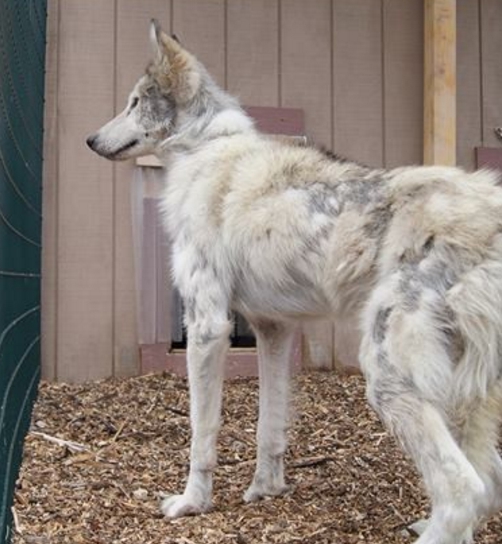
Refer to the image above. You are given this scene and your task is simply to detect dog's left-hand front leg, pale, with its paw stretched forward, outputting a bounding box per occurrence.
[162,302,231,518]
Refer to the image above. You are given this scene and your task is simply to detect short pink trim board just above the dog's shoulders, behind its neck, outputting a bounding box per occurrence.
[244,106,305,136]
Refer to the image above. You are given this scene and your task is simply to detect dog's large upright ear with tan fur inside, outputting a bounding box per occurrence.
[150,19,200,102]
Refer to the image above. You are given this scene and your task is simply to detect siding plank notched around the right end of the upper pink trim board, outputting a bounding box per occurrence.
[280,0,332,147]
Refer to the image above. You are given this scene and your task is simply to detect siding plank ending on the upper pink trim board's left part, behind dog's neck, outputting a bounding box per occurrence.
[226,0,279,106]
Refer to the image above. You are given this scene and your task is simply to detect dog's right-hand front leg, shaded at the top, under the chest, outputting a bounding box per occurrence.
[244,321,294,502]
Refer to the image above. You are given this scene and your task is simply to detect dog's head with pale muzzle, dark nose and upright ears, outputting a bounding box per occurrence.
[87,20,201,160]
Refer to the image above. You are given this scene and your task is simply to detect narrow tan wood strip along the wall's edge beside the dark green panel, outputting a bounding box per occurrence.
[41,0,59,380]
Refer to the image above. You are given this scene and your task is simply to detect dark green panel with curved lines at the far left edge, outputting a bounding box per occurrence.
[0,0,47,544]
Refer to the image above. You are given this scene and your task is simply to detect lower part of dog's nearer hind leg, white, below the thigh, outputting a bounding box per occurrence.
[370,386,485,544]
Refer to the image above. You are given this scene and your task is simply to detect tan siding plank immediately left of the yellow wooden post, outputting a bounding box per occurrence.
[383,0,424,167]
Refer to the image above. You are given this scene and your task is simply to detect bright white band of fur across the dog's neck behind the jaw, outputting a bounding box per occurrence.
[157,108,255,158]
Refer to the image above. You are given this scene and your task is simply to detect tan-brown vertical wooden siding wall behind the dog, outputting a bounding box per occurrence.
[42,0,502,381]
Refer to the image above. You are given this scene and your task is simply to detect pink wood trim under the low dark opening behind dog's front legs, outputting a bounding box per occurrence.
[140,332,302,378]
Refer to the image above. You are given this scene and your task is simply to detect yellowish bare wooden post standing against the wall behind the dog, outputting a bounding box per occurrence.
[424,0,456,165]
